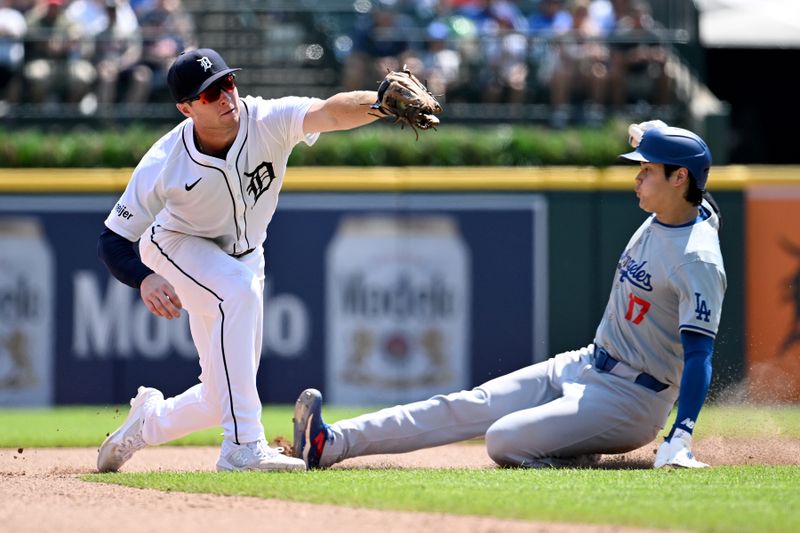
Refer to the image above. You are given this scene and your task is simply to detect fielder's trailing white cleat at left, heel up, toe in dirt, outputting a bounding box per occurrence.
[97,387,164,472]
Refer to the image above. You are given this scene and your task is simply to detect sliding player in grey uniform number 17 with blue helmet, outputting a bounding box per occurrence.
[294,121,726,468]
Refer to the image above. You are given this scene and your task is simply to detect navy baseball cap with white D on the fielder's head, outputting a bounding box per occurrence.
[167,48,242,102]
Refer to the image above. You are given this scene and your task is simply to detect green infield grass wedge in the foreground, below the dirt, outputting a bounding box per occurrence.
[83,466,800,532]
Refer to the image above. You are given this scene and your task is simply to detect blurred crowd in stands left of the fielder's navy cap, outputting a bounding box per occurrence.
[0,0,196,112]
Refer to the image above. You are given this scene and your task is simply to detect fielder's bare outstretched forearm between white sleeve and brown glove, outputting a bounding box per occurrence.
[303,91,379,134]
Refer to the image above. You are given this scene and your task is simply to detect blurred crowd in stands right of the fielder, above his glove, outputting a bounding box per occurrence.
[345,0,673,127]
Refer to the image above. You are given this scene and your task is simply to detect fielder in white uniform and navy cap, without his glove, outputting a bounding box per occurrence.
[97,48,384,472]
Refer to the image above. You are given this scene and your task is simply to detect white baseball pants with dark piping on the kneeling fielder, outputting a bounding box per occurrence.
[139,226,264,445]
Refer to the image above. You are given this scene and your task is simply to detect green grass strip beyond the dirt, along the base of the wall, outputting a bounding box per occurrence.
[0,405,800,448]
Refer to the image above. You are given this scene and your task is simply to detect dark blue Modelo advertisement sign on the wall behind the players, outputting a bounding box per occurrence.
[0,193,549,405]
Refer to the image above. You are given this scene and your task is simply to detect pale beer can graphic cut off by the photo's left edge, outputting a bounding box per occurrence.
[0,218,54,406]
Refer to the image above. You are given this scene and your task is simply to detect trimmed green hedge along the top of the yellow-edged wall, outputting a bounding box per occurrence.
[0,123,627,168]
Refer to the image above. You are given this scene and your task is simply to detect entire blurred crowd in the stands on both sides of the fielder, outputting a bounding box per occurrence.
[0,0,674,128]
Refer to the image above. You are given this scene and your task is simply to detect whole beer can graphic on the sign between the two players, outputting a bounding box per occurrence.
[325,216,470,404]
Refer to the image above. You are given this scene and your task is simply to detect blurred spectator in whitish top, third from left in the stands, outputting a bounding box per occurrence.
[93,0,153,104]
